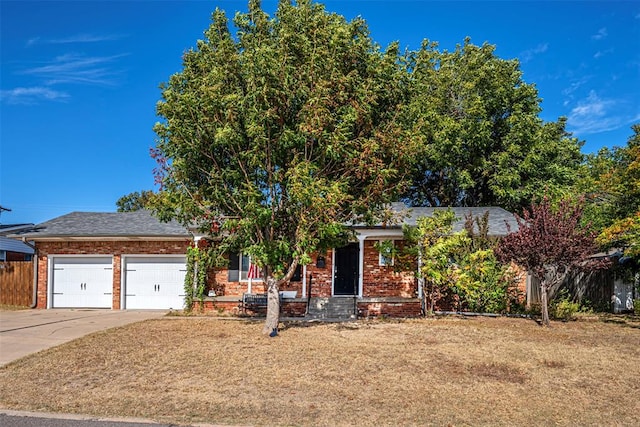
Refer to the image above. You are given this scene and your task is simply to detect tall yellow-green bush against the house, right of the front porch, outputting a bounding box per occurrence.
[388,209,520,313]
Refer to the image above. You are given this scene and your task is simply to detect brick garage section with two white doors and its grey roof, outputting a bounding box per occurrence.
[11,211,192,309]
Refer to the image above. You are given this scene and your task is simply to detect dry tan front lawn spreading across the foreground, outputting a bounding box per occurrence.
[0,318,640,426]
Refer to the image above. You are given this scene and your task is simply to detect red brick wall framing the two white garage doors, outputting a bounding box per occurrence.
[37,240,189,309]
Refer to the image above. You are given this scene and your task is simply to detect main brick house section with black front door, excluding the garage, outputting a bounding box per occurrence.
[204,203,517,318]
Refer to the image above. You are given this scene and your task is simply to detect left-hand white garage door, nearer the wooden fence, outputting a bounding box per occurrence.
[51,257,113,308]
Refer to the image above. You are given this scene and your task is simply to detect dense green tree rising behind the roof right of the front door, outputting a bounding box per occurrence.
[405,39,582,211]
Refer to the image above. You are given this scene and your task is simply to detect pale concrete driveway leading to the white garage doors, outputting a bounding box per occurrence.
[0,309,167,366]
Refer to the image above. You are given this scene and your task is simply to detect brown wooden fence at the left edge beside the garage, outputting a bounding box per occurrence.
[0,261,33,306]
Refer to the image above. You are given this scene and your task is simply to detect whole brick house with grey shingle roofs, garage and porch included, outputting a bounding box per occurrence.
[12,204,516,317]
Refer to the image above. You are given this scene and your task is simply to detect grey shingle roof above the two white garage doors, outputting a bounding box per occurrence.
[11,210,190,240]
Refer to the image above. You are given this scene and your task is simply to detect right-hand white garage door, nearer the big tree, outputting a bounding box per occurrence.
[124,256,187,310]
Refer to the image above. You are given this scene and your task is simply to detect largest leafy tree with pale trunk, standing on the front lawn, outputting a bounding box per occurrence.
[153,0,414,334]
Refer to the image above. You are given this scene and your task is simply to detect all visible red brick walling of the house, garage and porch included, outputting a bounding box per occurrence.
[37,240,420,317]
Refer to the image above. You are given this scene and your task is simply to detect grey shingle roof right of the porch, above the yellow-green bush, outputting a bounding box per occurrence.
[360,203,518,237]
